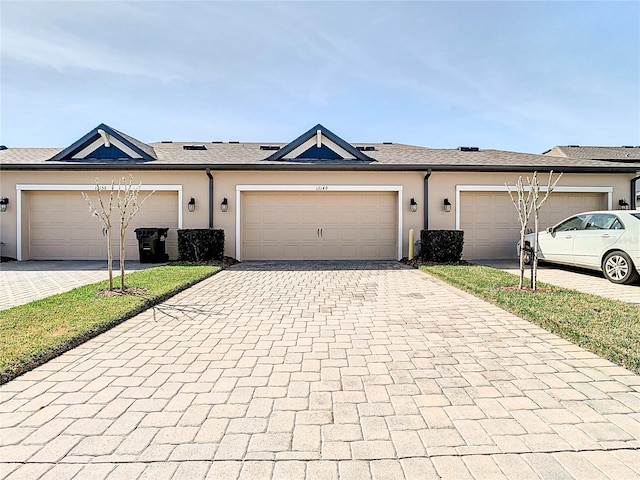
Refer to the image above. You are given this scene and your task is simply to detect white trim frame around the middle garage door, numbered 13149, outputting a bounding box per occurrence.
[236,185,402,260]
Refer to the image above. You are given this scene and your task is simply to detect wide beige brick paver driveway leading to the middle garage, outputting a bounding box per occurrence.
[0,262,640,480]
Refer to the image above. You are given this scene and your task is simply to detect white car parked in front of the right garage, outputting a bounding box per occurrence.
[518,210,640,284]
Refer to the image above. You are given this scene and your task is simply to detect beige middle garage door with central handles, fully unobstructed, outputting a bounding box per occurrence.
[241,192,398,260]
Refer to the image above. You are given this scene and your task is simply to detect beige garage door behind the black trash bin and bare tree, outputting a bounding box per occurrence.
[25,191,178,261]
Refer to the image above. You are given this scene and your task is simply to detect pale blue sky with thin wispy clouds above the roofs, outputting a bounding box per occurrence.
[0,0,640,153]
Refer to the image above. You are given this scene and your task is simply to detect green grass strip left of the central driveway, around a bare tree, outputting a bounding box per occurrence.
[0,265,221,384]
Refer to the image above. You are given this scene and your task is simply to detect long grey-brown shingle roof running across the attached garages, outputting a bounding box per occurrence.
[0,142,640,172]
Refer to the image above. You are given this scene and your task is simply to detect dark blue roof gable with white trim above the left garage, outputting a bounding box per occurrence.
[49,123,157,163]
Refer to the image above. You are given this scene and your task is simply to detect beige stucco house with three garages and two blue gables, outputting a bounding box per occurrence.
[0,124,640,260]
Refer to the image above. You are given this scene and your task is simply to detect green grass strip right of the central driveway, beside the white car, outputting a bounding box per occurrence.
[420,265,640,373]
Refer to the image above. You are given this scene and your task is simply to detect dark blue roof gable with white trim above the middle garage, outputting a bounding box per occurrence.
[265,124,375,163]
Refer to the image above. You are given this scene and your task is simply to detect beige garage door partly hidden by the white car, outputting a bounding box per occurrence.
[459,192,607,259]
